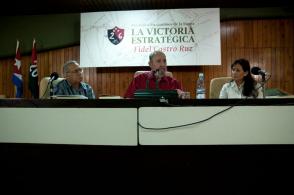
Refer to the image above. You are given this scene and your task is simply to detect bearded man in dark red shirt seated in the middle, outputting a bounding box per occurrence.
[124,51,184,98]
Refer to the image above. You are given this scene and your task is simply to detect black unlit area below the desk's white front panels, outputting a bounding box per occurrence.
[0,144,294,194]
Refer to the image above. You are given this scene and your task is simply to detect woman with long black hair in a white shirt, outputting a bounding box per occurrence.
[219,59,263,99]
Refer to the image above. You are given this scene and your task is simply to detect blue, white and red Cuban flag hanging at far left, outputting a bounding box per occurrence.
[12,41,23,98]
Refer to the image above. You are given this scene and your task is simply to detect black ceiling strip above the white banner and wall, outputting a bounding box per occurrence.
[0,0,293,16]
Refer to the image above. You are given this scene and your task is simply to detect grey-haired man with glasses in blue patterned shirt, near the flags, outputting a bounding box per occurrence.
[54,60,95,99]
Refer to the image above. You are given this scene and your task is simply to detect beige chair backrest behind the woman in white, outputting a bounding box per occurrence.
[209,77,232,99]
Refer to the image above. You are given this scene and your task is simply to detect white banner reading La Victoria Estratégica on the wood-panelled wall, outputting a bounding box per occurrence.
[80,8,221,67]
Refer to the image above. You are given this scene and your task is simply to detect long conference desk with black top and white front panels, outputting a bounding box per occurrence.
[0,98,294,146]
